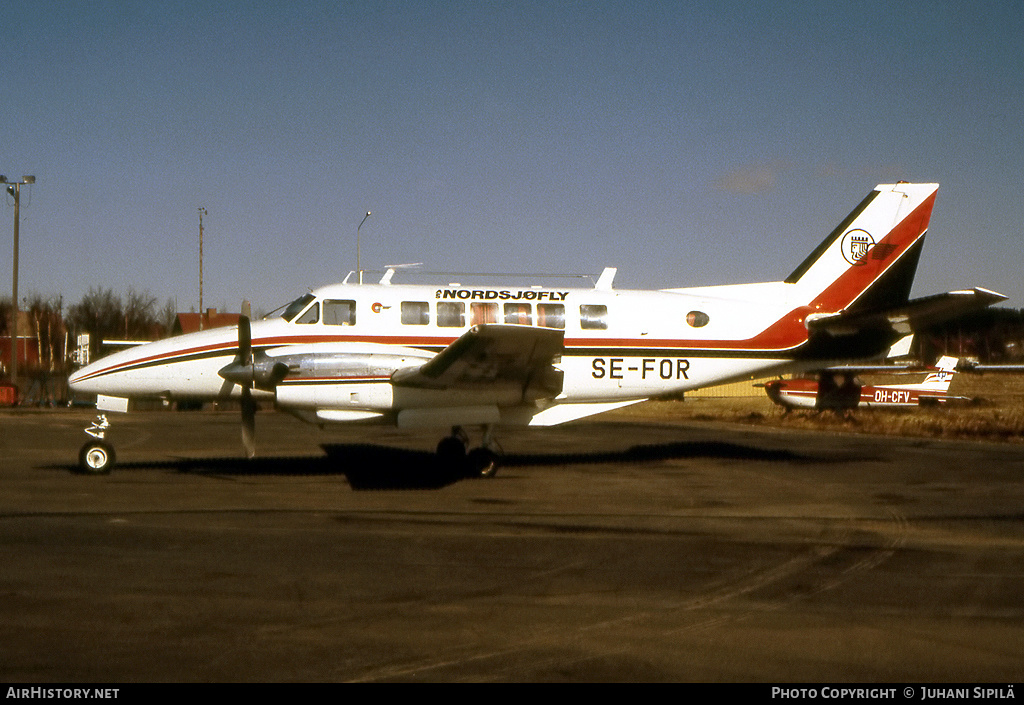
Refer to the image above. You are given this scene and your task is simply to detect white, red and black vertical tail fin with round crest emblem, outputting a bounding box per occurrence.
[785,181,939,314]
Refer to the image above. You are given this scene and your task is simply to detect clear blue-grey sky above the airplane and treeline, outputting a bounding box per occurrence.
[0,0,1024,310]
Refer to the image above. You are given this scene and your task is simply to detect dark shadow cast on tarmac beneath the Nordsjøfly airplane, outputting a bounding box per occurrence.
[58,441,823,490]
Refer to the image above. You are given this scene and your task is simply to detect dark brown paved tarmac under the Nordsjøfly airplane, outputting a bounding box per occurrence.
[0,410,1024,683]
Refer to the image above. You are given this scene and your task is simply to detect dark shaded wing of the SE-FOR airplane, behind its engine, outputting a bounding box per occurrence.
[391,324,564,400]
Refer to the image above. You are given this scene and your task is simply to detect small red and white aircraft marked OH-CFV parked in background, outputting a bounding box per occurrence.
[764,356,959,411]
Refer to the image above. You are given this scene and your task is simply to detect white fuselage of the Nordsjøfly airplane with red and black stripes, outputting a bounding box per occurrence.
[71,283,807,425]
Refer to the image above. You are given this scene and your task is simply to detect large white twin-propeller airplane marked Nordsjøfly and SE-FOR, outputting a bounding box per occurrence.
[69,182,1006,475]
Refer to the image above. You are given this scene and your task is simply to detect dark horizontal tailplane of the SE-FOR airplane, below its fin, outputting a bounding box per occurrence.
[807,288,1007,336]
